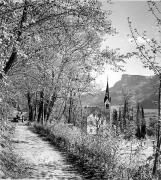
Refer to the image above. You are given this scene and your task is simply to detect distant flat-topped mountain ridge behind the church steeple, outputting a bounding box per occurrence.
[82,74,157,109]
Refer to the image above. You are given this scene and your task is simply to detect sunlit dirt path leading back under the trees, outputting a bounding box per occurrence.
[13,124,83,180]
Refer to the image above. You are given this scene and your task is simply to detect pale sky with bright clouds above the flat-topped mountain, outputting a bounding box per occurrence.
[96,0,158,89]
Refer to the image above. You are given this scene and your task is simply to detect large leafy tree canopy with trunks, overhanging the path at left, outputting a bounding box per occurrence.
[0,0,127,126]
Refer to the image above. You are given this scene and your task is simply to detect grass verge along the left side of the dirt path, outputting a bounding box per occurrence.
[0,120,31,179]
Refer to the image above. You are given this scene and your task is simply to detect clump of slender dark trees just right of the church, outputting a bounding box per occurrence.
[111,89,146,140]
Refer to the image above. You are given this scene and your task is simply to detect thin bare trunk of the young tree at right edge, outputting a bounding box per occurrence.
[152,74,161,175]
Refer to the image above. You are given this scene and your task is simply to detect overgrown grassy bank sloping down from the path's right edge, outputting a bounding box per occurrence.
[31,123,158,180]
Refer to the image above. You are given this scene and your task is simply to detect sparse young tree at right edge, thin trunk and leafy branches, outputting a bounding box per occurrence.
[128,1,161,175]
